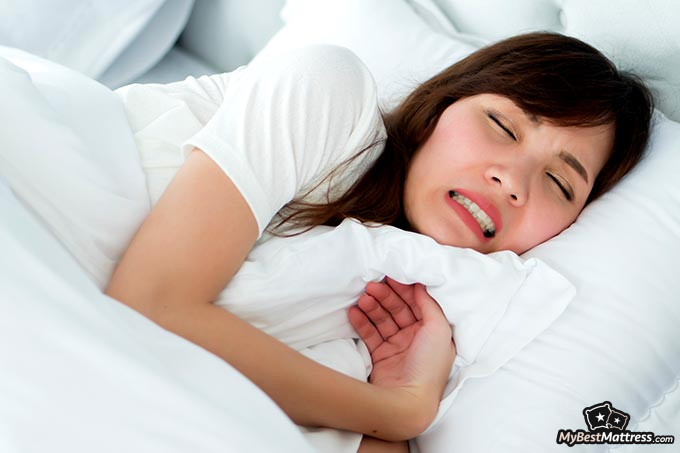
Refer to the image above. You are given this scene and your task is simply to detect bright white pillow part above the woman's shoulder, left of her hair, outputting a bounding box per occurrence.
[255,0,475,108]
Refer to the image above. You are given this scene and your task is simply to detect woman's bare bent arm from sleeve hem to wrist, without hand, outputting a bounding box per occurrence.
[106,150,443,440]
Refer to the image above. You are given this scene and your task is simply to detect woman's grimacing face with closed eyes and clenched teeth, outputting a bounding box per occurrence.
[404,94,614,254]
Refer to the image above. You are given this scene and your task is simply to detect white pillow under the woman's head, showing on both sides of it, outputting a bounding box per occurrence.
[263,0,680,446]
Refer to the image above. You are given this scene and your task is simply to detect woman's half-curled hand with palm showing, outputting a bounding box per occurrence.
[349,278,456,426]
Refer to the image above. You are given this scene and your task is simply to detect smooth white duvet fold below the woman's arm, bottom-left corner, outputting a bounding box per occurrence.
[0,177,314,453]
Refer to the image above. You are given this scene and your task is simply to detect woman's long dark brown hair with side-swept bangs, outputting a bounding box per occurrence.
[270,33,653,230]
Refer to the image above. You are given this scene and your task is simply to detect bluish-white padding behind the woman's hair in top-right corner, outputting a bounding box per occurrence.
[430,0,680,121]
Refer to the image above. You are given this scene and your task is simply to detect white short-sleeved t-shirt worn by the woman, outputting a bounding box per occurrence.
[116,46,385,235]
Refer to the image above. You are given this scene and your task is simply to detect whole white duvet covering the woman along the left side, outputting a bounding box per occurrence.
[0,48,310,453]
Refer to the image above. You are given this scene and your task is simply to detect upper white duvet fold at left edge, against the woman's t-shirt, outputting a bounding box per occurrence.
[0,46,150,288]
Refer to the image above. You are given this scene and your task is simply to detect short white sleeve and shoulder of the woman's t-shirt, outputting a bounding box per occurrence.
[182,46,384,235]
